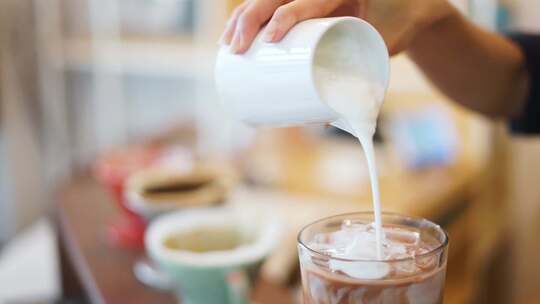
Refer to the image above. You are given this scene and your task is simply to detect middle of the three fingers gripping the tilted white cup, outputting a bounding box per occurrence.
[230,0,286,54]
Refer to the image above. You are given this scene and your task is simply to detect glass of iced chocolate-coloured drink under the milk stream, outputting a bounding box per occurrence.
[299,213,448,304]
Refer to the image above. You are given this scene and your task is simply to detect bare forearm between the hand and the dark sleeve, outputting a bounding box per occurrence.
[408,7,528,117]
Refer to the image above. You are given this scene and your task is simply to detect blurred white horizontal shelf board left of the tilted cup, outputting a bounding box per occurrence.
[61,37,217,79]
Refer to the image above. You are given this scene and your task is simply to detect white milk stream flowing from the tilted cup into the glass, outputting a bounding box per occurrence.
[314,23,385,260]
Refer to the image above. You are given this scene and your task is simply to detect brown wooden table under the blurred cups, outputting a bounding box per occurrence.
[56,174,294,304]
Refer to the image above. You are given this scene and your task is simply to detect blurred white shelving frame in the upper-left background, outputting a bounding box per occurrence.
[35,0,227,164]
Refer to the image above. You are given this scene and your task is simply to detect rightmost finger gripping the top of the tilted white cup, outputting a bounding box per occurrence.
[263,0,342,42]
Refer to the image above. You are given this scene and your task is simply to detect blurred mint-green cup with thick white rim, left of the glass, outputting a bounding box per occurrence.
[145,206,282,304]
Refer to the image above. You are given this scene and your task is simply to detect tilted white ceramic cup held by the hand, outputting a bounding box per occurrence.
[215,17,390,131]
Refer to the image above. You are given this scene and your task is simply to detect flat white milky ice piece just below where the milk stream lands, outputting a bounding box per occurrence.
[329,260,390,280]
